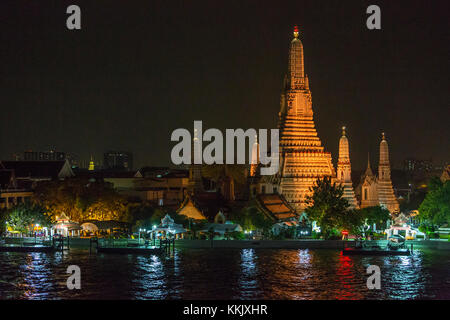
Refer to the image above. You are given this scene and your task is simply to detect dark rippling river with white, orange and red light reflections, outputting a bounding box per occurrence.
[0,249,450,299]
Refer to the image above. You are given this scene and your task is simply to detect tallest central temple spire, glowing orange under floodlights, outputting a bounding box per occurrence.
[279,27,335,210]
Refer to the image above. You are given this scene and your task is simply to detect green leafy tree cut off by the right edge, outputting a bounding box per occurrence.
[419,177,450,226]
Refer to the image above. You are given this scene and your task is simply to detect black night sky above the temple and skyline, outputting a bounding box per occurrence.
[0,0,450,169]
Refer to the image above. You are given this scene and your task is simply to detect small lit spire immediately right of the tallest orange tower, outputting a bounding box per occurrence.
[336,127,358,209]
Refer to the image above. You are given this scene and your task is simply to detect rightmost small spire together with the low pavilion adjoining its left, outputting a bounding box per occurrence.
[357,133,400,213]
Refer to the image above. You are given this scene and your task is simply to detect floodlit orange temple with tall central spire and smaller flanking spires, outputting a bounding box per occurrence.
[250,27,399,213]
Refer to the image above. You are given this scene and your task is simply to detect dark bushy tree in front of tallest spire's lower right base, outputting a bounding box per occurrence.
[305,177,357,238]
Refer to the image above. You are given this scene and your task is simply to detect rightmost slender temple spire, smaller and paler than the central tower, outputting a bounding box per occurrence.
[378,132,400,213]
